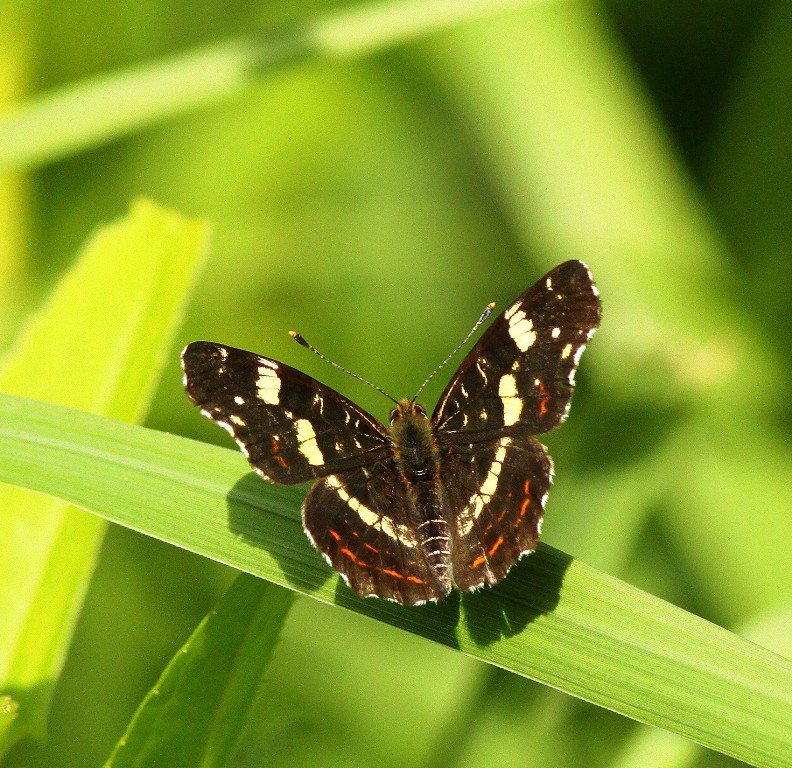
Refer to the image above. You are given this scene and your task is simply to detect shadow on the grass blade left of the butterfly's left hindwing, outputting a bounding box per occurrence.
[226,472,333,592]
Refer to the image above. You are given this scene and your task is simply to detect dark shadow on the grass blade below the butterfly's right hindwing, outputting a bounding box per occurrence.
[462,544,573,646]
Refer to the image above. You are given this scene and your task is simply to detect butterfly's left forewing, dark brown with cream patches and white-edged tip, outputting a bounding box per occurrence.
[182,341,390,484]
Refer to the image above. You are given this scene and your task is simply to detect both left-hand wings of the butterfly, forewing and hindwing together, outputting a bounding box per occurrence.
[182,341,451,605]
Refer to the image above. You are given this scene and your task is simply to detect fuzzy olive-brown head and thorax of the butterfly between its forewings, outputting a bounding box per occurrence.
[390,400,439,483]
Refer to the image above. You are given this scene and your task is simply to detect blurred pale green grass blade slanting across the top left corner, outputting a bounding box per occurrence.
[0,0,536,173]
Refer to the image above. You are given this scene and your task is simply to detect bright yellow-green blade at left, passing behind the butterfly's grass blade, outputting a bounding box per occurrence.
[0,202,206,752]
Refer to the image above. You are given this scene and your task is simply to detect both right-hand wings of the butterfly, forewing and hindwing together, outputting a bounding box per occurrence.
[432,261,600,589]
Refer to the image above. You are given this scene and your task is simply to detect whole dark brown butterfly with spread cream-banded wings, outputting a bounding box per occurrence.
[182,261,601,605]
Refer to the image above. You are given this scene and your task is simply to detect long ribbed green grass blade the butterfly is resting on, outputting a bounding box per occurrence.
[0,396,792,768]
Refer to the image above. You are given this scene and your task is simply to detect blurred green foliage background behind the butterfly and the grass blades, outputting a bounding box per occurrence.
[0,0,792,768]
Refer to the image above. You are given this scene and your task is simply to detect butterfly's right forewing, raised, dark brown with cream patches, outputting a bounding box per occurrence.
[432,261,600,444]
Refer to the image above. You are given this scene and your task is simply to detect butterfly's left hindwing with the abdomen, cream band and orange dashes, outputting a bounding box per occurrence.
[303,462,451,605]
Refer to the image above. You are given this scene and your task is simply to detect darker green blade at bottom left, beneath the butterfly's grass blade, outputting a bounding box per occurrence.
[105,574,294,768]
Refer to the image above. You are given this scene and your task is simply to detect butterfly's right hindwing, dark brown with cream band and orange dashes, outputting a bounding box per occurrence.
[441,437,553,589]
